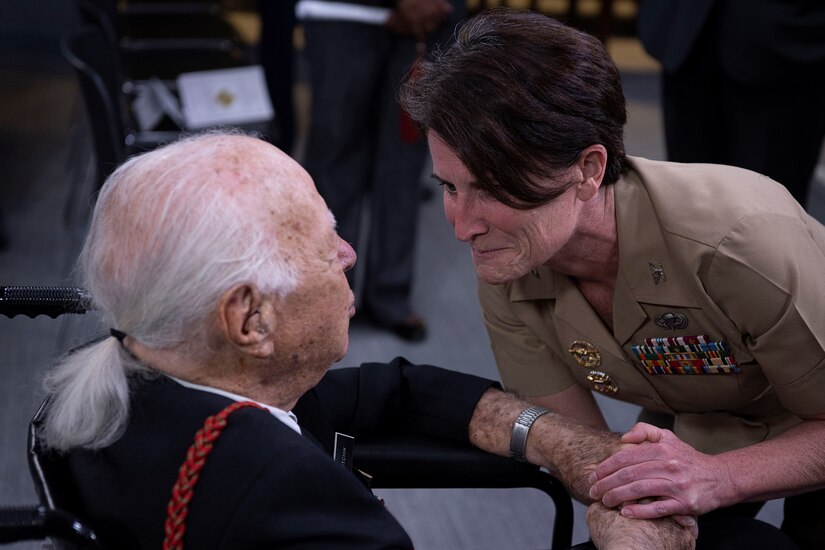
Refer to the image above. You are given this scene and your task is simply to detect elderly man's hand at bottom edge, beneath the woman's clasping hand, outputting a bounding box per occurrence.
[587,502,697,550]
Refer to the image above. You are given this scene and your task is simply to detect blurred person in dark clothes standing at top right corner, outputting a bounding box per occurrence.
[638,0,825,206]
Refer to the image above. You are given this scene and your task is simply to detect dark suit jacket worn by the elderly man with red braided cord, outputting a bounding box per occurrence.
[62,359,493,549]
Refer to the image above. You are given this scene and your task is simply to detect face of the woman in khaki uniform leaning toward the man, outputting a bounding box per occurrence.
[427,131,577,284]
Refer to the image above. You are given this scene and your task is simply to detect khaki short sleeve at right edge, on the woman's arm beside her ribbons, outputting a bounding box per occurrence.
[704,211,825,416]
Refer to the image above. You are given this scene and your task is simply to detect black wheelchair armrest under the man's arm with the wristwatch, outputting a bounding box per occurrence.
[353,435,573,548]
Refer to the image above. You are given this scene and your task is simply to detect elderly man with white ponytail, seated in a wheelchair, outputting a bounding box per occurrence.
[43,134,693,548]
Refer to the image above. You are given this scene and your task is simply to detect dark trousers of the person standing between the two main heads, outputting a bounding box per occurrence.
[304,21,427,322]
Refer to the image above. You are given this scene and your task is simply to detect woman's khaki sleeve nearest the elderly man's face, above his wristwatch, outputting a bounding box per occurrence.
[478,280,576,397]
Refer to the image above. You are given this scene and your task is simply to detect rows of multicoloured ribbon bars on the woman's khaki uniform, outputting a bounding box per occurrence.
[631,335,740,375]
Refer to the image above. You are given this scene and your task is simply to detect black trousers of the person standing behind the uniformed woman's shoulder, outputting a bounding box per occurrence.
[662,13,825,205]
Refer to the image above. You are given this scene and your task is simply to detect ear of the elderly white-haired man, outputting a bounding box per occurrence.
[218,284,275,358]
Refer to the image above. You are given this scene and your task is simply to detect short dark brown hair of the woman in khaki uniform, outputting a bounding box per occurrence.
[400,9,627,208]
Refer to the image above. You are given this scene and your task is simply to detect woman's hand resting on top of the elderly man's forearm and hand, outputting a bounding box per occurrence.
[590,423,735,518]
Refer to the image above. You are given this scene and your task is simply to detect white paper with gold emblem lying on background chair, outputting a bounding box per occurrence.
[177,65,274,130]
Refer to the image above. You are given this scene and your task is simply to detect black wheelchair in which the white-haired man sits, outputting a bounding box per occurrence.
[0,286,573,548]
